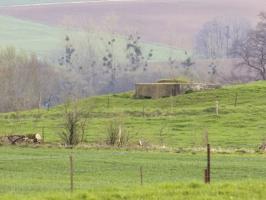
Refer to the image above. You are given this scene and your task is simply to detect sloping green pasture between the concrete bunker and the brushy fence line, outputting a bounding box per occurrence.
[0,81,266,150]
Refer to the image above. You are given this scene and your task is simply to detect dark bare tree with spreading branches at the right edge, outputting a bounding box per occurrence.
[233,13,266,80]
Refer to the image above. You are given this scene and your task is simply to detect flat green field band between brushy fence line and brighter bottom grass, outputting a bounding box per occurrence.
[0,147,266,196]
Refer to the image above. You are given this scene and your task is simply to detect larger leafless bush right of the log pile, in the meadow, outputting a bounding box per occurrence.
[60,101,86,146]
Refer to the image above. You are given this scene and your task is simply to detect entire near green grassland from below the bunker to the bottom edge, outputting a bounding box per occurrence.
[0,81,266,200]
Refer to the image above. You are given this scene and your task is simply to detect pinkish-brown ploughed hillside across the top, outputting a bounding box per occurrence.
[0,0,265,49]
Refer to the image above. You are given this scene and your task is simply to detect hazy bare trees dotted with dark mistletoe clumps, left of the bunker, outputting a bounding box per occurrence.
[56,30,153,97]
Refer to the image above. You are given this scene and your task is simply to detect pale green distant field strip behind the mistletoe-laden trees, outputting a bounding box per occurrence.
[0,16,187,62]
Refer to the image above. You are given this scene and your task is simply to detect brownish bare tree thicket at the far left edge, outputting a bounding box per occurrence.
[0,47,59,112]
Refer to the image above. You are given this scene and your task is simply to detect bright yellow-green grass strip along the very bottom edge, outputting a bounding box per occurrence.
[0,181,266,200]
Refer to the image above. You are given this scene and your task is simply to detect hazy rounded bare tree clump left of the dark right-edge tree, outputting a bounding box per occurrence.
[195,18,250,59]
